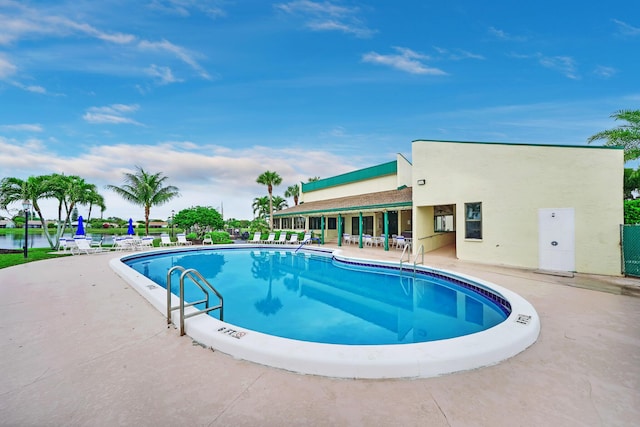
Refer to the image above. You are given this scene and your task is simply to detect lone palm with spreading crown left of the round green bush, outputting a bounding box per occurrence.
[107,166,180,235]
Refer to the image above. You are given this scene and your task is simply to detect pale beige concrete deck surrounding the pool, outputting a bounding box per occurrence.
[0,246,640,426]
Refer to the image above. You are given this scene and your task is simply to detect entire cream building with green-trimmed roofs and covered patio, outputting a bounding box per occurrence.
[274,140,624,275]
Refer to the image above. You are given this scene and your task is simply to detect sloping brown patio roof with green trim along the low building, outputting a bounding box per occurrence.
[273,187,413,218]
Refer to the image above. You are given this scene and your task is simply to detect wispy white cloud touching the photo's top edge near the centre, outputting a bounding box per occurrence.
[274,0,375,38]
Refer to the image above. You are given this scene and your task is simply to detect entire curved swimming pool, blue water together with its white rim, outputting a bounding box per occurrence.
[112,245,539,378]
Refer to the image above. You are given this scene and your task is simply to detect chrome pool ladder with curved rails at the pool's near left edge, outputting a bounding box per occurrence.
[167,265,224,336]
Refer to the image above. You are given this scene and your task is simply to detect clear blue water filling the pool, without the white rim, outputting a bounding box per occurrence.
[125,248,509,345]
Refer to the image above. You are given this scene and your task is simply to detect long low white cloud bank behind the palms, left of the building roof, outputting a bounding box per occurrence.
[0,136,360,219]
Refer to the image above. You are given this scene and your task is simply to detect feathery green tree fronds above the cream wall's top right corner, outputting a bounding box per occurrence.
[587,110,640,161]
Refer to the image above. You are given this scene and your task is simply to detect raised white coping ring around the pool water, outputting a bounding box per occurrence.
[109,245,540,379]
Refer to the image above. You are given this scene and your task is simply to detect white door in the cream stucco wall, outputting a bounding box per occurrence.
[538,208,576,271]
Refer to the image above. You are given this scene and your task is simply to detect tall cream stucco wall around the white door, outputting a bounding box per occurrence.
[412,141,624,275]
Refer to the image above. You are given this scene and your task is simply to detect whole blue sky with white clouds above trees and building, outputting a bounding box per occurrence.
[0,0,640,219]
